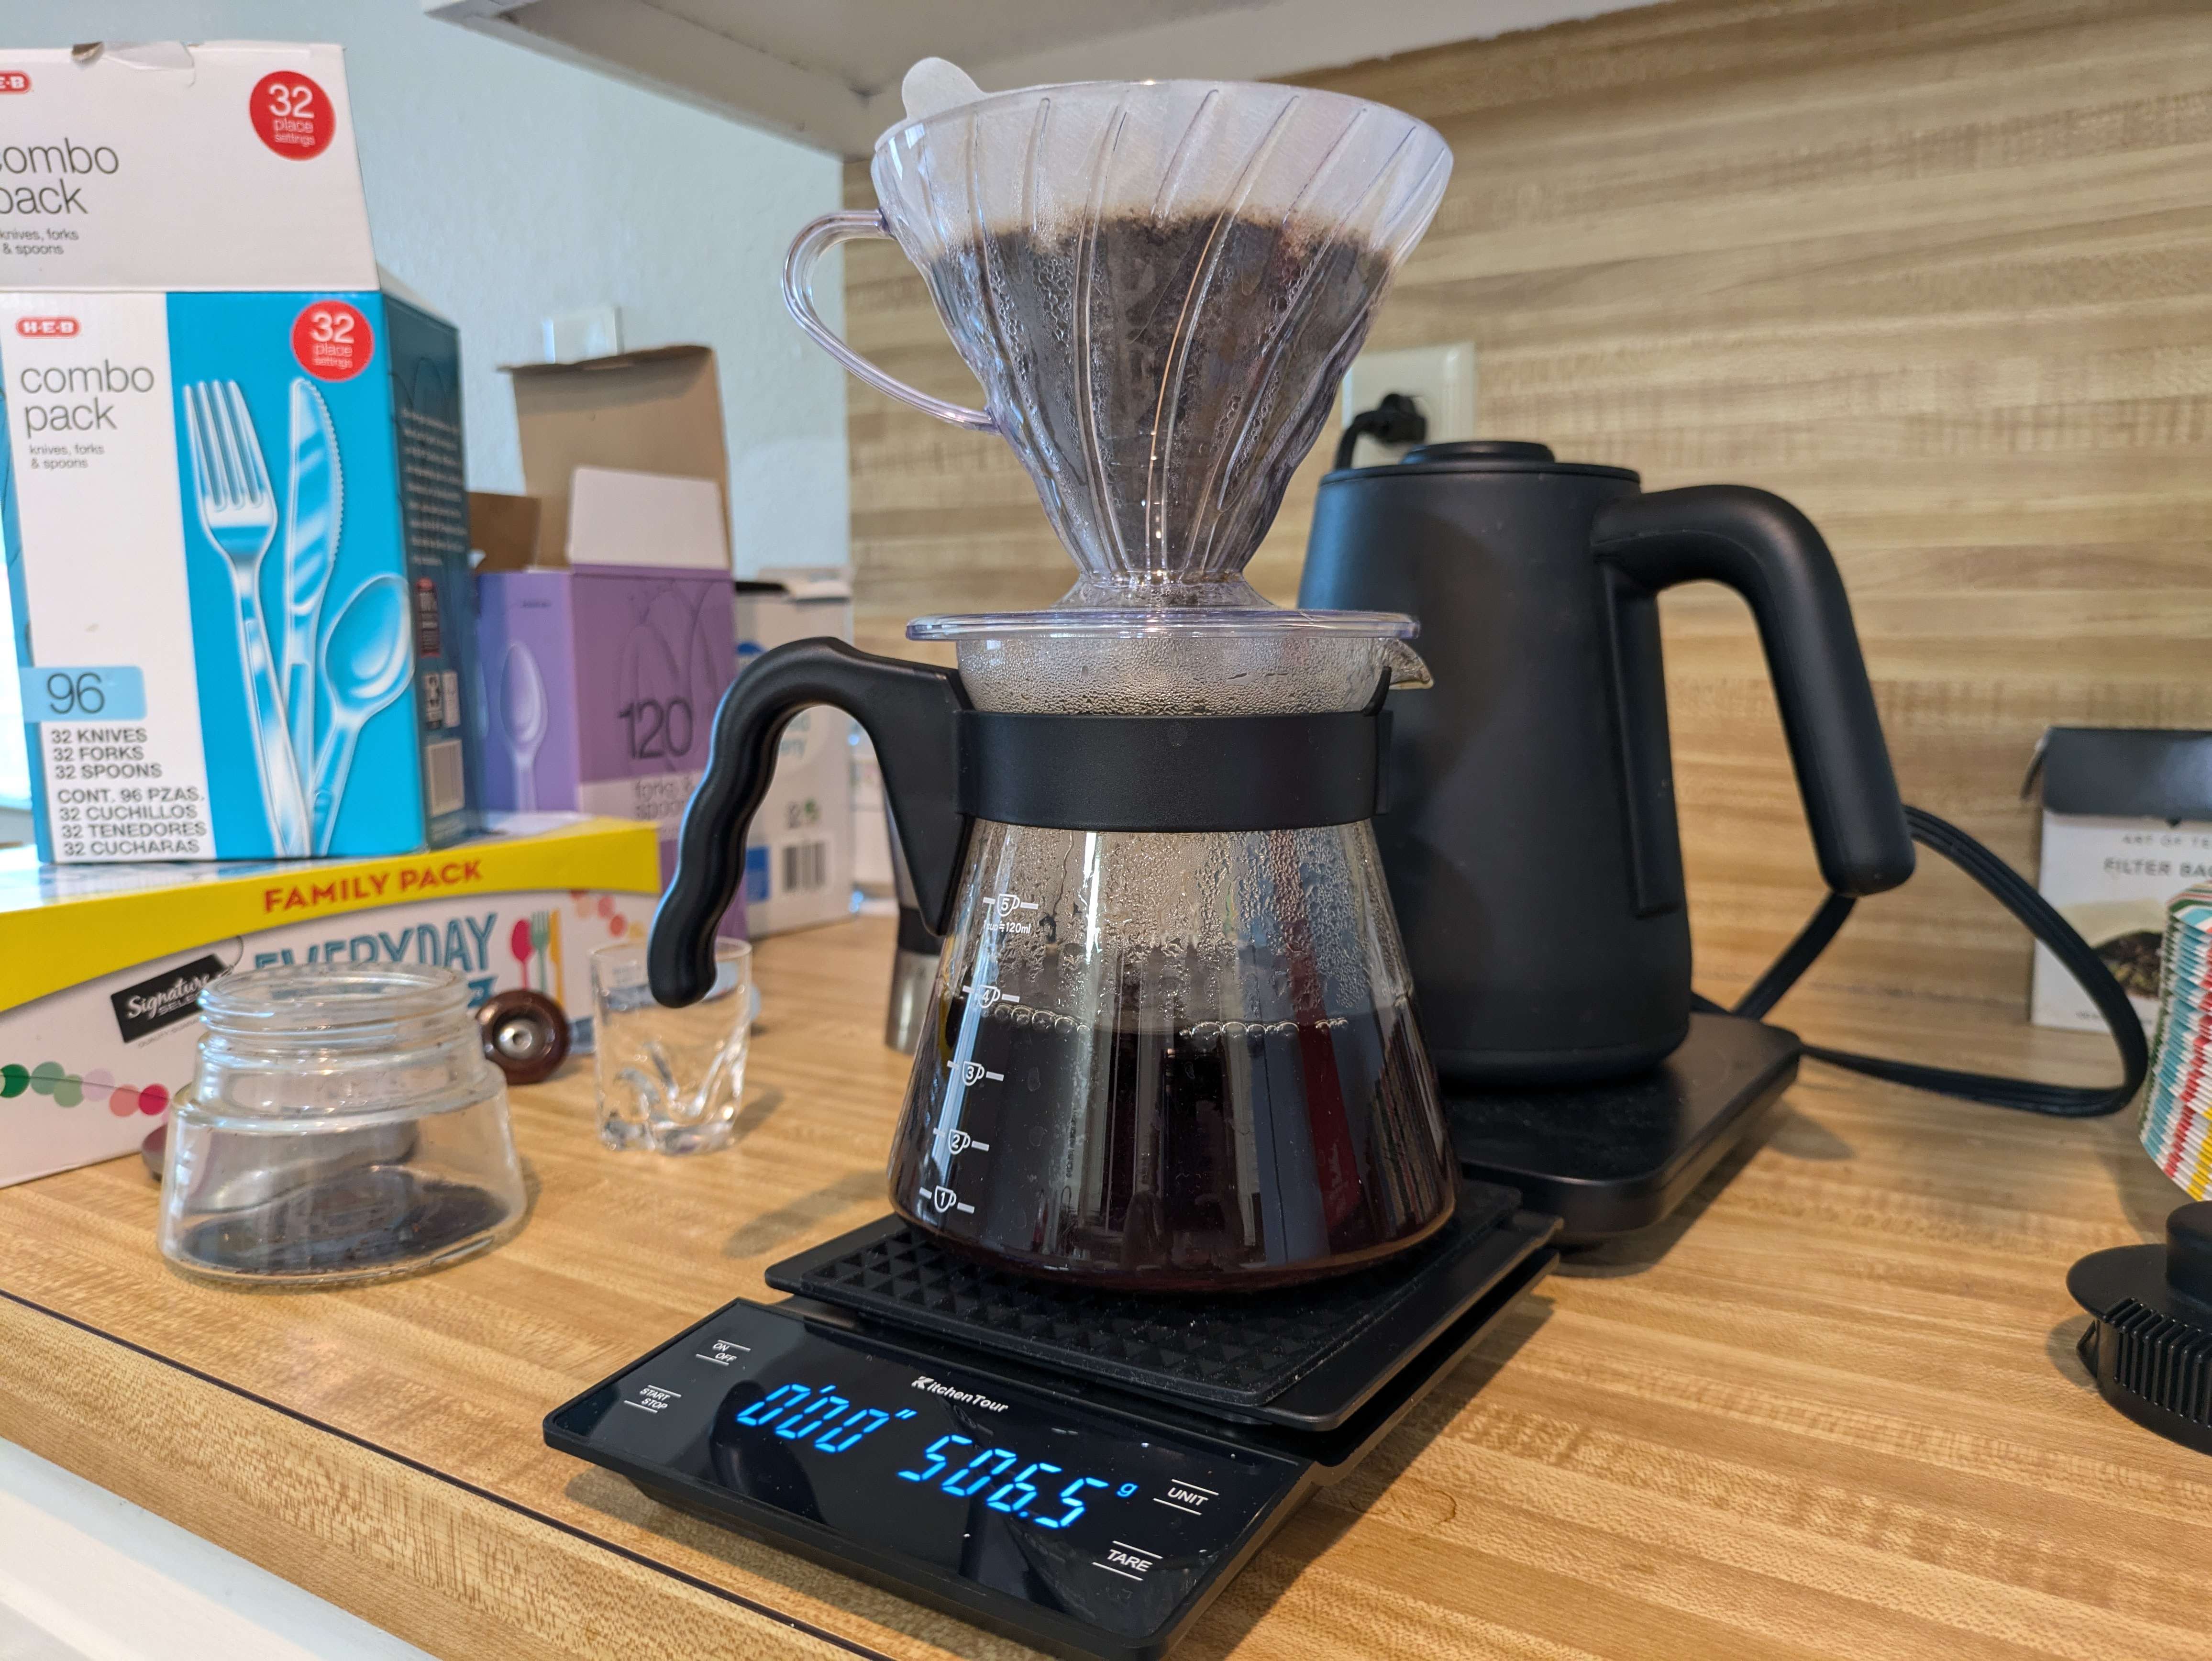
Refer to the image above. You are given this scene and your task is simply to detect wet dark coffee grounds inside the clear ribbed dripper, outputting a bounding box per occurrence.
[927,214,1389,575]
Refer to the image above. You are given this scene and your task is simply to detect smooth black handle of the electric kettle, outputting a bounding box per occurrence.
[1593,484,1913,898]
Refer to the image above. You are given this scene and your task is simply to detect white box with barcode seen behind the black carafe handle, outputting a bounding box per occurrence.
[737,568,854,938]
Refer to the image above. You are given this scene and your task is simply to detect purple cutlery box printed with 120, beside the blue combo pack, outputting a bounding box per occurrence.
[476,566,743,933]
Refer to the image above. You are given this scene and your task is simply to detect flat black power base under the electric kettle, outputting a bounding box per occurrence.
[1444,1013,1803,1245]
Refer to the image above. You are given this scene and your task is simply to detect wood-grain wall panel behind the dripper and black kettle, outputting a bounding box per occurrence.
[845,0,2212,1015]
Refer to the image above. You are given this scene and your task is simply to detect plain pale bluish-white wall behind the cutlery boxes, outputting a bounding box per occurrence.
[0,0,845,798]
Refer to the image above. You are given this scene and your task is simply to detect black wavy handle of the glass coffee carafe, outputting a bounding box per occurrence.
[646,639,971,1008]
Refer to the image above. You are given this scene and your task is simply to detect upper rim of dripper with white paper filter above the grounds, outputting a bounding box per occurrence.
[872,57,1451,263]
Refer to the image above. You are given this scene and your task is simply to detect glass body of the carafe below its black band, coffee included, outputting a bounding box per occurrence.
[891,825,1451,1289]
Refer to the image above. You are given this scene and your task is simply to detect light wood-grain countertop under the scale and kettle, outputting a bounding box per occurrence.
[0,920,2212,1661]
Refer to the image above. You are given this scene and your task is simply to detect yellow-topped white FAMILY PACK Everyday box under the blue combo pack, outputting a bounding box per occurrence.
[0,814,659,1183]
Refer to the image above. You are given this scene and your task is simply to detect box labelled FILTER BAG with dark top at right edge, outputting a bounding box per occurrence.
[2028,728,2212,1033]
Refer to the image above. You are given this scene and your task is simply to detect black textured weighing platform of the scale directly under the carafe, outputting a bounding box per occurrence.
[768,1183,1522,1422]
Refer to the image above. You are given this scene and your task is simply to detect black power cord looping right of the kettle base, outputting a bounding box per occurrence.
[1697,807,2150,1119]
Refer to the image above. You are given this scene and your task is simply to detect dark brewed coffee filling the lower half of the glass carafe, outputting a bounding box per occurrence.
[891,1000,1456,1292]
